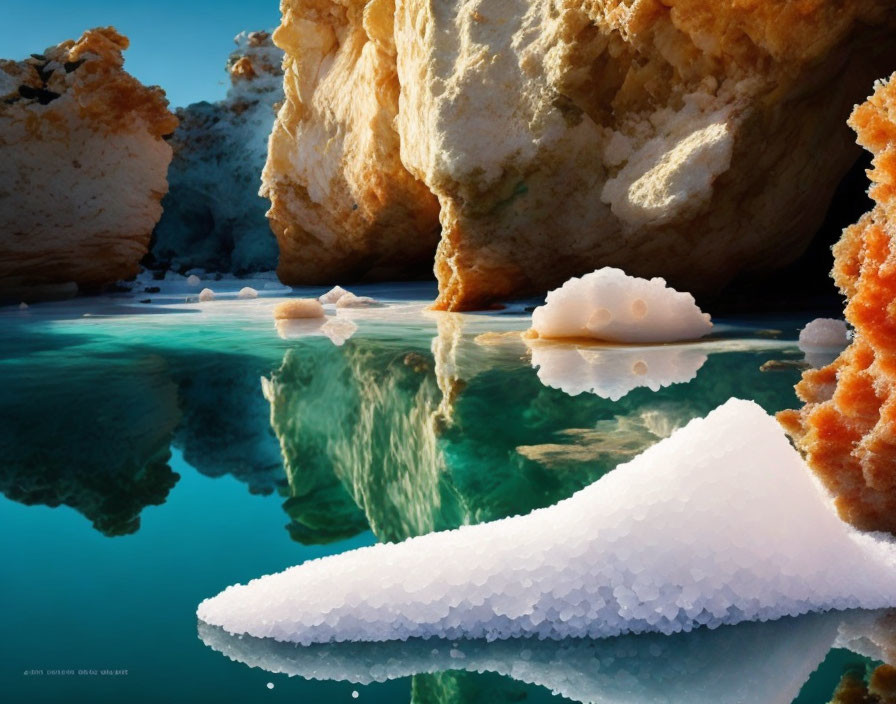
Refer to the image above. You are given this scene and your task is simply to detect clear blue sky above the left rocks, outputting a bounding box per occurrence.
[0,0,280,106]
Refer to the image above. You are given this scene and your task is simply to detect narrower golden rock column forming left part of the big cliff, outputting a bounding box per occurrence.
[262,0,439,284]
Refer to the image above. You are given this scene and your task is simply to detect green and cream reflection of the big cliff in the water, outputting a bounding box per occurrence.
[263,315,792,542]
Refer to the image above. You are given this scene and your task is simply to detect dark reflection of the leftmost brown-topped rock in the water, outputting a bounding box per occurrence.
[0,350,181,536]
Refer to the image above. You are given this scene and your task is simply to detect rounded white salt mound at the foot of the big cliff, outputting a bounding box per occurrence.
[532,267,712,342]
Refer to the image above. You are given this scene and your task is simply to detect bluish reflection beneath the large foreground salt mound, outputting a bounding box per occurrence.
[199,611,880,704]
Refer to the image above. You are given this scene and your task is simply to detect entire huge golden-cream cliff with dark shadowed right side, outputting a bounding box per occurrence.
[265,0,896,309]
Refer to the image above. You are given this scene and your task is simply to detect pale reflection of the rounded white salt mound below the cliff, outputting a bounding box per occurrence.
[530,341,707,401]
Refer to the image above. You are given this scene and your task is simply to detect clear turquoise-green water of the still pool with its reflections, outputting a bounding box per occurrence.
[0,285,870,704]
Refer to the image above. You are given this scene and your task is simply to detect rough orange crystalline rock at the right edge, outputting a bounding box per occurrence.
[779,74,896,533]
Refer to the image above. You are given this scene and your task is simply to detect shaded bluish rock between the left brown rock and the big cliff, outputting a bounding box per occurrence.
[152,32,283,274]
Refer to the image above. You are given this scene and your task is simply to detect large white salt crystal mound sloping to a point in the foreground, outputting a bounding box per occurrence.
[197,399,896,644]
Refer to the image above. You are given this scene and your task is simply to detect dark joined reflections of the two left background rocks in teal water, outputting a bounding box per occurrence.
[0,327,283,537]
